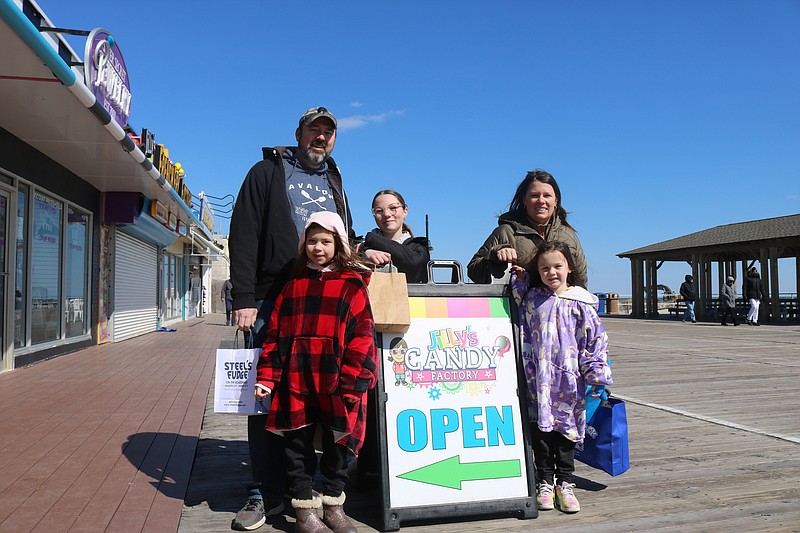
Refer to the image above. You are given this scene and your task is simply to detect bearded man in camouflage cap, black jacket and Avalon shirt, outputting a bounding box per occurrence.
[228,107,354,531]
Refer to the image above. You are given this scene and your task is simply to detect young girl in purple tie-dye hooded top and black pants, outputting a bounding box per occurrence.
[511,241,612,513]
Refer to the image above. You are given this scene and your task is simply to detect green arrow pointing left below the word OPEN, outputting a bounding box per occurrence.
[397,455,522,490]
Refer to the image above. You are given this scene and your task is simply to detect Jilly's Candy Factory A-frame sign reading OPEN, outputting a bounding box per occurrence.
[376,261,538,531]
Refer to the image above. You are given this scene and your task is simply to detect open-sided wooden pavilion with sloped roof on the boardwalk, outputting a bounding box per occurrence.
[617,215,800,322]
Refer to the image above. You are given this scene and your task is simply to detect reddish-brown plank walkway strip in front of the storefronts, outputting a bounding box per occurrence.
[0,317,224,532]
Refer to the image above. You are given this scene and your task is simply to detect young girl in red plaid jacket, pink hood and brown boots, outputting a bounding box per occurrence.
[255,211,378,533]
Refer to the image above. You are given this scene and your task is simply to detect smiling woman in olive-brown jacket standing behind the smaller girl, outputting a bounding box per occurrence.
[467,169,587,288]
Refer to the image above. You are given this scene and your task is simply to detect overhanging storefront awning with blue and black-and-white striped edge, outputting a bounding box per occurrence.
[0,0,199,231]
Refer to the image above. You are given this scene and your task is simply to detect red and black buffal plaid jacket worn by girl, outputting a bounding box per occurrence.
[257,269,378,453]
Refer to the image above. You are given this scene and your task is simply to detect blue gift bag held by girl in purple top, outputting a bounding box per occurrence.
[575,398,631,476]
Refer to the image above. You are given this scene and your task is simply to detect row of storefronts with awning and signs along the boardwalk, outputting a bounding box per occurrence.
[0,0,222,372]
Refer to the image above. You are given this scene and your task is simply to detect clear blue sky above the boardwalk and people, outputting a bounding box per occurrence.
[43,0,800,294]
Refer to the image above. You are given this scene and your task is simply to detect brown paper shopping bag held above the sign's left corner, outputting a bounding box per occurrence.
[368,272,411,333]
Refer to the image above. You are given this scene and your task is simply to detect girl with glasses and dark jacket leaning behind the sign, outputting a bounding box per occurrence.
[360,189,431,283]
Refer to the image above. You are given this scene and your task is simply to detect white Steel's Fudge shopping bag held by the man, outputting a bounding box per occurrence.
[214,339,272,415]
